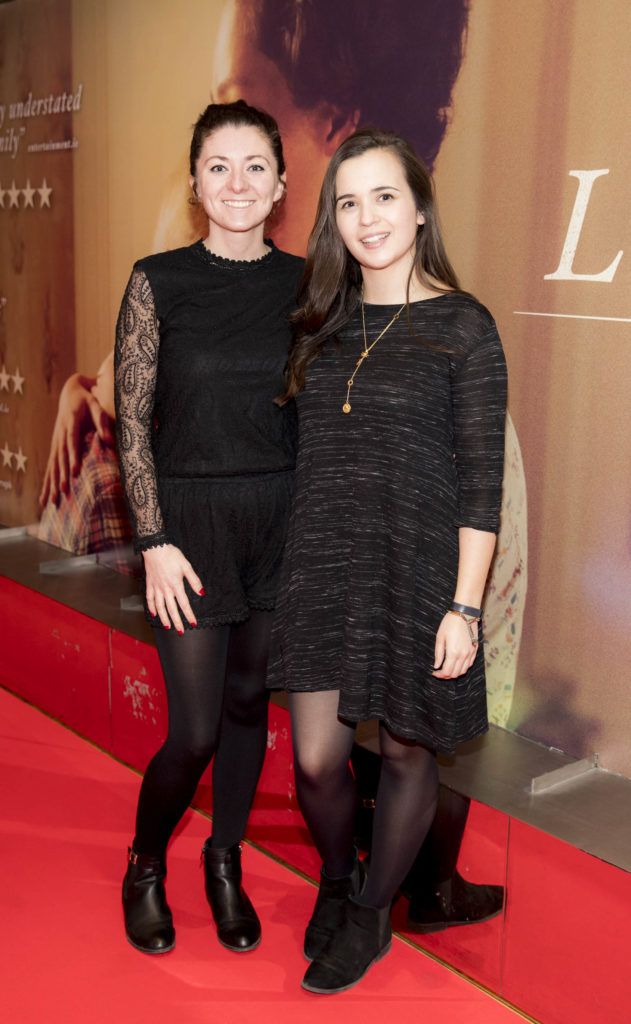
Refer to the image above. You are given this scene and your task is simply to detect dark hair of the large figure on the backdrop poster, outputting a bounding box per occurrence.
[256,0,470,168]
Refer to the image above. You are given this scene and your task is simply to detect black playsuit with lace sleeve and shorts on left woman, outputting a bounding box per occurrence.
[115,242,303,627]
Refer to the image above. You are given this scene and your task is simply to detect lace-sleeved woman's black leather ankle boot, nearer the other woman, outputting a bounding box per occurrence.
[202,840,261,953]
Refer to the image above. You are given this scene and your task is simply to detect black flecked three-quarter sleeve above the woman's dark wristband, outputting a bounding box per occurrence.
[452,326,507,534]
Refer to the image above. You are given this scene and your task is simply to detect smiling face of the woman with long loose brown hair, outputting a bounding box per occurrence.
[335,148,425,280]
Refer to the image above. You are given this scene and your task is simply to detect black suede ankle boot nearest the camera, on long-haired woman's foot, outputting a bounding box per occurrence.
[302,897,392,995]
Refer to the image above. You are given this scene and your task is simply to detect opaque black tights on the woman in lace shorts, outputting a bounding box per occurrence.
[134,611,271,857]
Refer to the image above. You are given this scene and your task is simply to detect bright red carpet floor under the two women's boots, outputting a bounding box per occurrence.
[0,690,517,1024]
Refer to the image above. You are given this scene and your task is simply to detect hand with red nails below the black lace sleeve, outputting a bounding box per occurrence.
[142,544,204,635]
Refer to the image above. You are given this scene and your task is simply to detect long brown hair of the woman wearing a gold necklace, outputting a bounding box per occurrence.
[277,127,461,406]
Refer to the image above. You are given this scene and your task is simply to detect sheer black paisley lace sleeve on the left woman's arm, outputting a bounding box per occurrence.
[115,268,169,552]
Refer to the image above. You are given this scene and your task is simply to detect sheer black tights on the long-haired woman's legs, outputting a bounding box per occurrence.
[289,690,438,907]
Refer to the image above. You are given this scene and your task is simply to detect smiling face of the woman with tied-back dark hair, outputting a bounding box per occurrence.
[191,125,284,238]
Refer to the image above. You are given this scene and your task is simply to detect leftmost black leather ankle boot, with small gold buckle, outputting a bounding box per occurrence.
[123,847,175,953]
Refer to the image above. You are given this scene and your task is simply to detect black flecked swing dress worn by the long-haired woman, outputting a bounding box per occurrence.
[268,292,506,753]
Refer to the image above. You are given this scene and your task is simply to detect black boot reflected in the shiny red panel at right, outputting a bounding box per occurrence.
[408,871,504,935]
